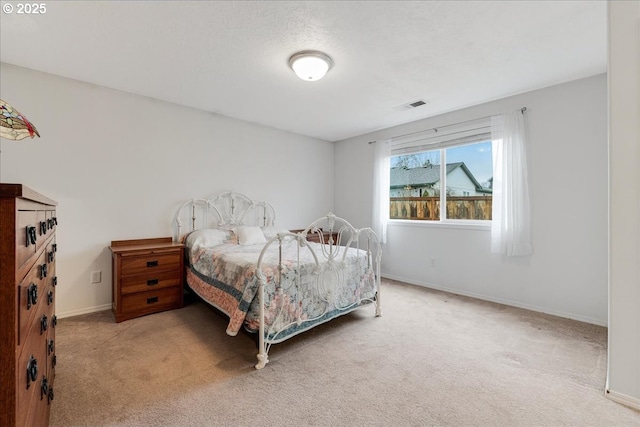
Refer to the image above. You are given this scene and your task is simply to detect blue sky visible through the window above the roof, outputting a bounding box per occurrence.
[391,141,493,184]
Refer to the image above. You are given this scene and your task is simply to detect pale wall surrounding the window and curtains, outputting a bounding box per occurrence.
[334,75,608,325]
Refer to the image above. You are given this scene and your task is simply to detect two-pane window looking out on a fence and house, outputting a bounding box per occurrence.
[389,140,493,221]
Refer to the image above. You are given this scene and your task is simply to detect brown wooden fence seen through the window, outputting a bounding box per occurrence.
[389,196,492,221]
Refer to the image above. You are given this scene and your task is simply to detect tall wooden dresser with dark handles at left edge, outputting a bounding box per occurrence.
[0,184,58,426]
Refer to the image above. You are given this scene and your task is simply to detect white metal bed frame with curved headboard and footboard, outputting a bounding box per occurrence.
[174,192,382,369]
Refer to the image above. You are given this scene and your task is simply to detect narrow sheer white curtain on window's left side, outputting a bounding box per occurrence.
[372,140,391,243]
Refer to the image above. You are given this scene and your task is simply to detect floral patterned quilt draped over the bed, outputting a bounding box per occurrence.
[187,236,376,343]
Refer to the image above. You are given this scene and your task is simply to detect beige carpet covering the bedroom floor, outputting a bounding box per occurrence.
[51,280,640,427]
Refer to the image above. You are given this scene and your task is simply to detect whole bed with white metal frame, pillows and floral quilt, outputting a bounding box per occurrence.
[174,192,381,369]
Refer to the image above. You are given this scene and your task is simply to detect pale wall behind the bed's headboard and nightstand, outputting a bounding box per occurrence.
[0,64,334,316]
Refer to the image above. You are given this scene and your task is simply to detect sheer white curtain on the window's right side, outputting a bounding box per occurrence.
[491,110,533,256]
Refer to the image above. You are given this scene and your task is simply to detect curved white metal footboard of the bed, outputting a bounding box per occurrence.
[255,213,381,369]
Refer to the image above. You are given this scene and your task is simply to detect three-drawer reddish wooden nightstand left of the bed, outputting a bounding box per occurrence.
[110,237,184,322]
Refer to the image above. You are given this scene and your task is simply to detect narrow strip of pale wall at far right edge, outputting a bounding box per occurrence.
[607,1,640,409]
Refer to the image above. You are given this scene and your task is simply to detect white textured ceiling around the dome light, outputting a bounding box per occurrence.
[0,1,607,141]
